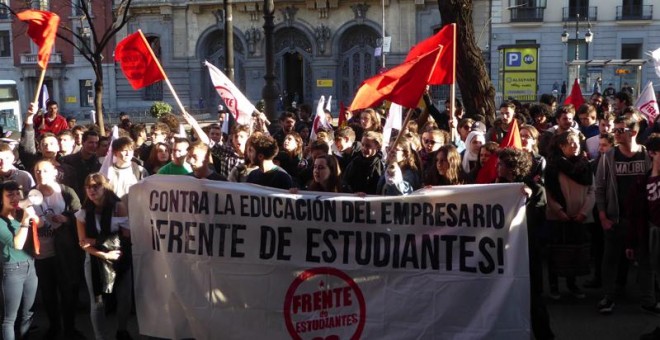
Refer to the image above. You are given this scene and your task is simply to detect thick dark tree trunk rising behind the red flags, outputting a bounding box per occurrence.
[438,0,496,125]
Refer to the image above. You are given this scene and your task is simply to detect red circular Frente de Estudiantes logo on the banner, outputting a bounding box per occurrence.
[284,267,366,340]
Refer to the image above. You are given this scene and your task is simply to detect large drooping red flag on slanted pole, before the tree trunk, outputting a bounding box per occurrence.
[351,46,442,110]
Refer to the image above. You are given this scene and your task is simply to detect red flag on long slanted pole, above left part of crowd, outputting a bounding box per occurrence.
[115,30,165,90]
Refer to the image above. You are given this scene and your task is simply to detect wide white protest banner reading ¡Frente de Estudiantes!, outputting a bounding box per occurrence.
[130,176,531,340]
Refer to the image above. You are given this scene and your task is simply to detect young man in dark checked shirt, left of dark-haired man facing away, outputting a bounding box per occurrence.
[211,124,250,178]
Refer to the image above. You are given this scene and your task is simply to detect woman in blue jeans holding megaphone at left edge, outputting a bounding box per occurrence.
[0,181,40,340]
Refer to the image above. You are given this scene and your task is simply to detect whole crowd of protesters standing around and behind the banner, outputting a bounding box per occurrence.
[0,87,660,340]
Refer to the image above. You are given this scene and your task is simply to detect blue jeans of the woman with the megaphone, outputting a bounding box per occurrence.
[2,260,38,340]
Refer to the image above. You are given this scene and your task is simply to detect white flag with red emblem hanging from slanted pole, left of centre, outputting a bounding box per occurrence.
[204,61,257,124]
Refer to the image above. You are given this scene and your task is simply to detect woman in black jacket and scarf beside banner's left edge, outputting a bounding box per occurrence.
[76,173,132,340]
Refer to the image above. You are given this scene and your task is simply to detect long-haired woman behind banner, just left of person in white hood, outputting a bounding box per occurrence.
[424,144,465,186]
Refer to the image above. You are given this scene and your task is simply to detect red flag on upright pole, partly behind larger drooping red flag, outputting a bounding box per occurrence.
[405,24,456,85]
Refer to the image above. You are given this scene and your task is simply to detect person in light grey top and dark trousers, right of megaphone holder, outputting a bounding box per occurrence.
[34,160,84,339]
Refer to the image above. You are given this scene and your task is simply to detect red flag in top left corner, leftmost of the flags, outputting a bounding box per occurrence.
[16,9,60,69]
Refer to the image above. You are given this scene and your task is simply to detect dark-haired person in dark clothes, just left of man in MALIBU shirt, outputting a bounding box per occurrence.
[545,130,595,299]
